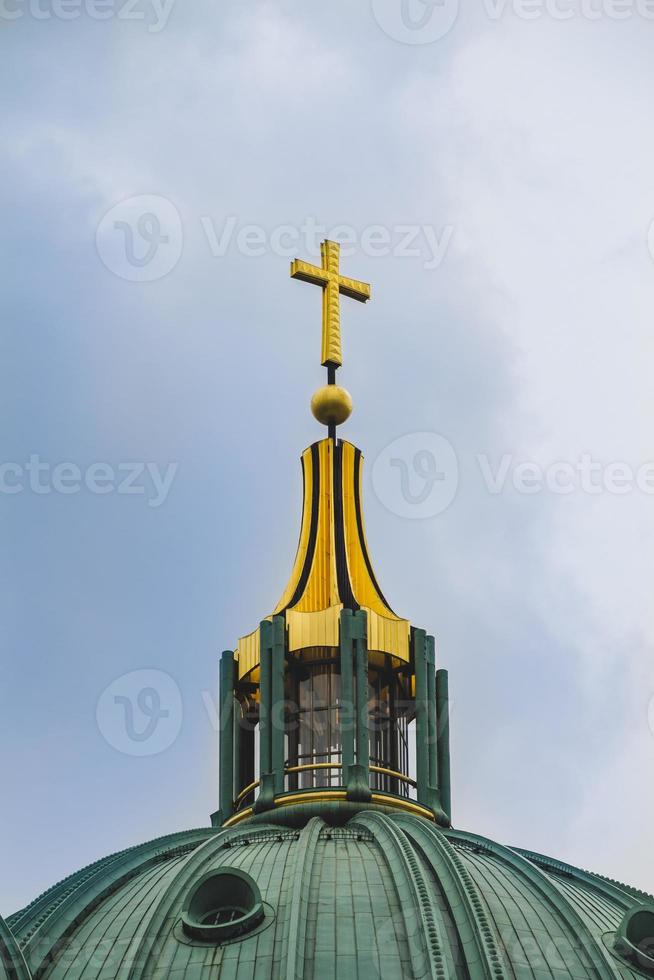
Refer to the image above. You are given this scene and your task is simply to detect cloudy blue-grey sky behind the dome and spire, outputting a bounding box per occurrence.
[0,0,654,914]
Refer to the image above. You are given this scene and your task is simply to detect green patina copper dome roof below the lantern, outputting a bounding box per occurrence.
[5,811,651,980]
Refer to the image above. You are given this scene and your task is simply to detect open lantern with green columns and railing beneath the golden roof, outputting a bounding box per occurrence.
[215,610,450,826]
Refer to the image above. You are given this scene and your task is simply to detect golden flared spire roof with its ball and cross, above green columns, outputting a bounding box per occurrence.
[237,241,410,685]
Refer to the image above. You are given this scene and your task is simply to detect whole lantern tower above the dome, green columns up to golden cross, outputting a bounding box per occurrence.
[218,241,450,826]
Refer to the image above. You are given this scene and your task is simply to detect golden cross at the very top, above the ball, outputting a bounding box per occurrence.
[291,241,370,368]
